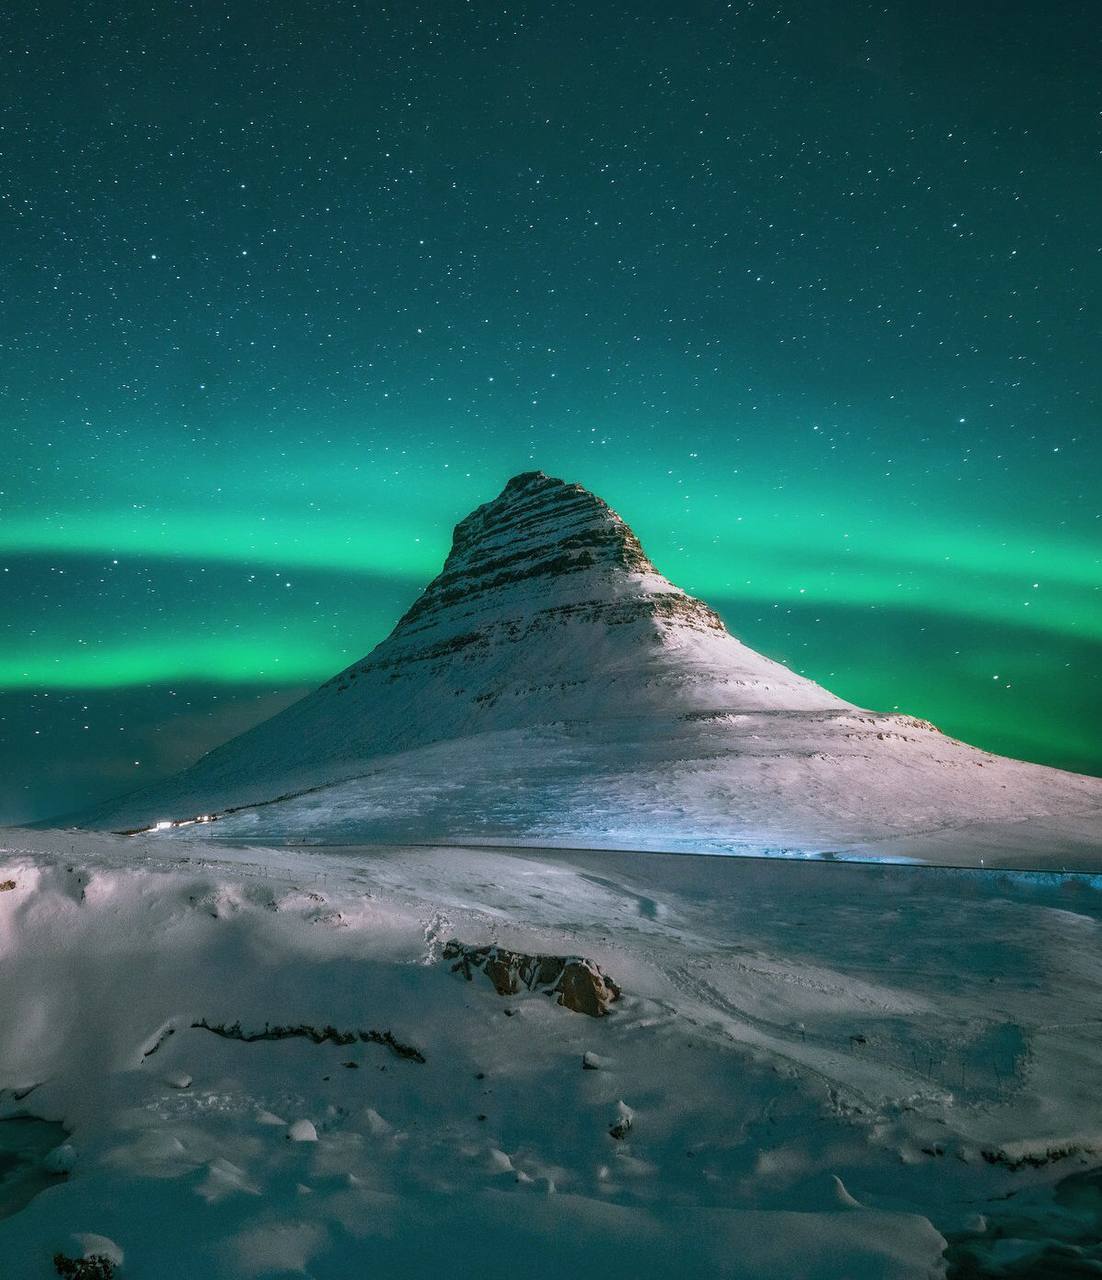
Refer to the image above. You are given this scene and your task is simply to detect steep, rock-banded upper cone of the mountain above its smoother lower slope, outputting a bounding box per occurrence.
[77,471,849,829]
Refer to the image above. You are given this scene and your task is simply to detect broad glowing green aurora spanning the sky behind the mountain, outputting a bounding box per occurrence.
[0,458,1102,788]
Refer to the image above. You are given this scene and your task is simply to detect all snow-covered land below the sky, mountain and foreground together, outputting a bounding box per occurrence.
[10,474,1102,1280]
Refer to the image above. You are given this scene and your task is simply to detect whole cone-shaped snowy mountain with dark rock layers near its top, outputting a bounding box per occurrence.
[71,471,1102,865]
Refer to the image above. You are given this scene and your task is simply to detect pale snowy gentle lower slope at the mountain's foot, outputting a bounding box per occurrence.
[82,712,1102,870]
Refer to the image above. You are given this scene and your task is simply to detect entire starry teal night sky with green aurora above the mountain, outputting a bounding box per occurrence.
[0,0,1102,822]
